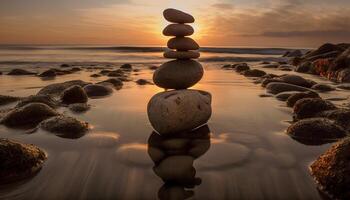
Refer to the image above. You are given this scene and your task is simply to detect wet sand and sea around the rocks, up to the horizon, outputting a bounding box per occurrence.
[0,46,349,199]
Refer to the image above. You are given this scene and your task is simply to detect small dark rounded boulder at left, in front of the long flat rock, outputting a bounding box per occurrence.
[61,85,88,104]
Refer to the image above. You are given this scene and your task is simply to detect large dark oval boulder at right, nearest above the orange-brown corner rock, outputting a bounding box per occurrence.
[287,118,346,145]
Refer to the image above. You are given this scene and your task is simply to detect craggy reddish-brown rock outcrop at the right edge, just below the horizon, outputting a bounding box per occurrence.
[290,43,350,83]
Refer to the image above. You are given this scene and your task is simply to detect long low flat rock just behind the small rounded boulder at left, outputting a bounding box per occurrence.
[38,80,89,95]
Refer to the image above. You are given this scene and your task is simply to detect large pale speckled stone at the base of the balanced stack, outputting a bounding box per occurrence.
[147,90,211,134]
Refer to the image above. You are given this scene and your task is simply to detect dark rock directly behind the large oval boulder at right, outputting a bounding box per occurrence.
[293,98,337,120]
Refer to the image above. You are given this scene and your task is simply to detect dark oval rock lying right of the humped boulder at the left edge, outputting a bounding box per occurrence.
[40,115,89,139]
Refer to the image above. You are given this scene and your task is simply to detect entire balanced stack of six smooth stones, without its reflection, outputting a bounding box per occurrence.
[148,9,211,135]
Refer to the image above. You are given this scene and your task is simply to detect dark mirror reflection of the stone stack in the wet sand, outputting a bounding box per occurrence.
[148,126,210,199]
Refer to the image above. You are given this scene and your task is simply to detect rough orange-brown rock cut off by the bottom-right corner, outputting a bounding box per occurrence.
[310,138,350,199]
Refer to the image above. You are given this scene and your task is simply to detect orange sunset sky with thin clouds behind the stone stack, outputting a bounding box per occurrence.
[0,0,350,47]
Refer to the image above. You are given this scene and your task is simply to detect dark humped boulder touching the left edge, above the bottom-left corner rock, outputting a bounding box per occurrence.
[1,103,59,128]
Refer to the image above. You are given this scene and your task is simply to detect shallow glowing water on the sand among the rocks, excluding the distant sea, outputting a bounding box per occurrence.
[0,57,348,199]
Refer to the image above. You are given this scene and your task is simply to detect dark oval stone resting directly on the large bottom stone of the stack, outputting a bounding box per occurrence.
[153,60,204,89]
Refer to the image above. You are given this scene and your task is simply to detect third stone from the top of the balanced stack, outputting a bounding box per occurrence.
[167,37,199,51]
